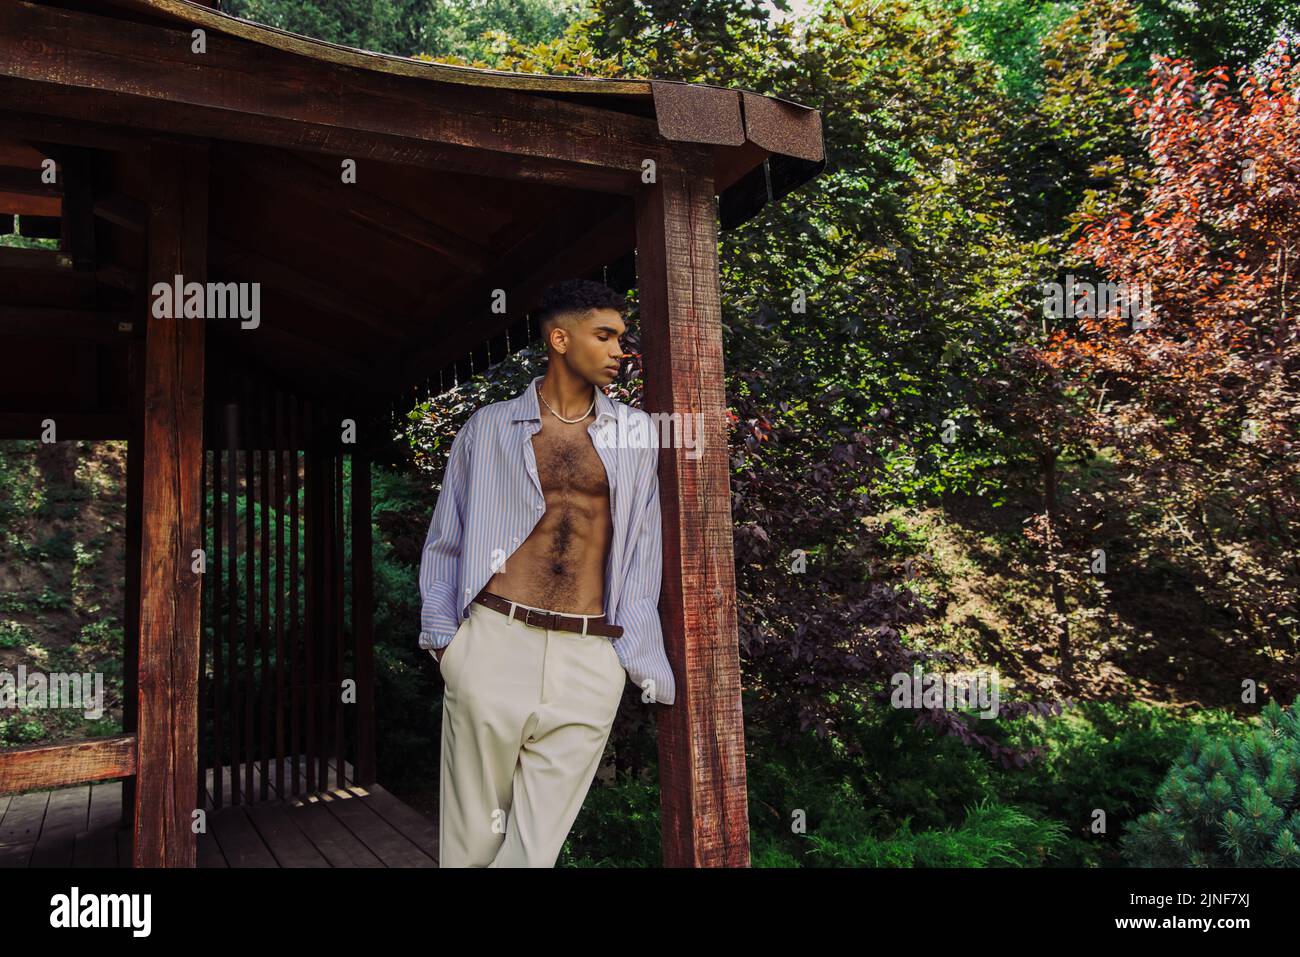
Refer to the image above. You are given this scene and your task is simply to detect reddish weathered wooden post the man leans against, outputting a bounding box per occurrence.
[636,147,749,867]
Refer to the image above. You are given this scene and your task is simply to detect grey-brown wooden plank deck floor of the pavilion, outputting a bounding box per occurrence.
[0,761,438,867]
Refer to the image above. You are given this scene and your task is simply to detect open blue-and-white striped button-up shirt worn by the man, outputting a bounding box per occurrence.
[419,376,676,705]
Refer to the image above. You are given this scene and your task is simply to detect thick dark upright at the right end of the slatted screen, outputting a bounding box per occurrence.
[352,442,376,787]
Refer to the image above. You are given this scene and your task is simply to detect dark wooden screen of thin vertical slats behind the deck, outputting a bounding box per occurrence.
[192,374,374,802]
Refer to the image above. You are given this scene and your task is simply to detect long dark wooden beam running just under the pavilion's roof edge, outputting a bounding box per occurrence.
[0,0,671,191]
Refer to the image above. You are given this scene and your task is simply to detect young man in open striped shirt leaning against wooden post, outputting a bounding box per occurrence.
[420,280,676,867]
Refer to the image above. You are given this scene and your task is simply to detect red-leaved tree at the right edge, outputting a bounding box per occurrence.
[1062,44,1300,680]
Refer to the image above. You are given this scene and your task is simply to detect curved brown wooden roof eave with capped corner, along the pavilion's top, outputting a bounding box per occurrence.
[0,0,824,229]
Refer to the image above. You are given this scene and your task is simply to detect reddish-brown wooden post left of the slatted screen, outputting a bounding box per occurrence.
[133,143,208,867]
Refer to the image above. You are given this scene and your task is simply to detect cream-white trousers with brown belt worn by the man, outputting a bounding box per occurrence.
[438,602,627,867]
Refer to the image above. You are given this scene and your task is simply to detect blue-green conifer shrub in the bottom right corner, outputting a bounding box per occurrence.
[1122,698,1300,867]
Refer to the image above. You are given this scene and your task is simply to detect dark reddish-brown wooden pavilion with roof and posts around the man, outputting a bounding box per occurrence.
[0,0,823,867]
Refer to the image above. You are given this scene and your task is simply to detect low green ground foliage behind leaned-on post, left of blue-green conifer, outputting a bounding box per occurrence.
[562,702,1216,867]
